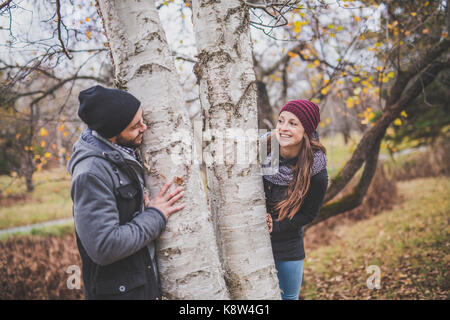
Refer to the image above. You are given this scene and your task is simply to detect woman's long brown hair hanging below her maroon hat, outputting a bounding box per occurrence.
[267,133,327,221]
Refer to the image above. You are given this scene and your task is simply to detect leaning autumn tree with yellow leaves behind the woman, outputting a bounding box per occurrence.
[239,1,449,223]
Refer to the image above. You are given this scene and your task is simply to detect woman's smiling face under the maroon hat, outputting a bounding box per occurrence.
[275,111,305,148]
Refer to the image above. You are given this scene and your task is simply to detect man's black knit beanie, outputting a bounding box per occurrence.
[78,85,141,138]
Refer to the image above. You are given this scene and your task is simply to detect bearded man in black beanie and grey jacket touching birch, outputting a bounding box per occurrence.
[68,85,184,299]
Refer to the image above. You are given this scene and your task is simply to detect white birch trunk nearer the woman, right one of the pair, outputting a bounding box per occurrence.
[192,0,280,299]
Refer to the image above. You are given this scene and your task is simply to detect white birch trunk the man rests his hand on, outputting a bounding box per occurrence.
[97,0,228,299]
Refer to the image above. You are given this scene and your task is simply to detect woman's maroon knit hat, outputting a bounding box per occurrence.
[278,100,320,137]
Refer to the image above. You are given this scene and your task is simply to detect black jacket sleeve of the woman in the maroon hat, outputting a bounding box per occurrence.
[272,169,328,234]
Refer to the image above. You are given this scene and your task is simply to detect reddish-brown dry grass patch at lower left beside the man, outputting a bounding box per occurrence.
[0,233,83,300]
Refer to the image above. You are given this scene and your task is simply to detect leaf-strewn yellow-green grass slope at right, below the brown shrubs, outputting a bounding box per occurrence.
[302,177,450,299]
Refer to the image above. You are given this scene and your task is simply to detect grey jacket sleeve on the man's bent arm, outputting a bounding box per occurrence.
[71,172,166,265]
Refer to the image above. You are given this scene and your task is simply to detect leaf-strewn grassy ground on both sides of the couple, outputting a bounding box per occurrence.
[0,138,450,300]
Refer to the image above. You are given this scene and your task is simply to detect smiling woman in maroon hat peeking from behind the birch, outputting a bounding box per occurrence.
[263,100,328,300]
